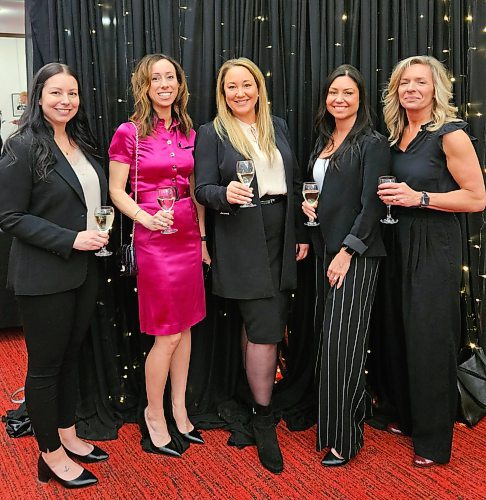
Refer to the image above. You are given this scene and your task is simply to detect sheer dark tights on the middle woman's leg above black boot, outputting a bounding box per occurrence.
[241,327,277,406]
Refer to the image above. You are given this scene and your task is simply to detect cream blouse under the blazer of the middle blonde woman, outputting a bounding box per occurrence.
[236,119,287,198]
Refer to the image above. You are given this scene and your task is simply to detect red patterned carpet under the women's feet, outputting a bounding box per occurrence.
[0,331,486,500]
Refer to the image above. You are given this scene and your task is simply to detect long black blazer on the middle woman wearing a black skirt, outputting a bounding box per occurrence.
[195,117,307,299]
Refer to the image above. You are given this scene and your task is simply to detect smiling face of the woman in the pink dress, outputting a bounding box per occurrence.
[148,59,179,116]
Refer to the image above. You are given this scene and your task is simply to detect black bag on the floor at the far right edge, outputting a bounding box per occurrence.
[457,346,486,427]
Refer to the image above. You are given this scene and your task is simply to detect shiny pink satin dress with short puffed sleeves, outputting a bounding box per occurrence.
[109,120,206,335]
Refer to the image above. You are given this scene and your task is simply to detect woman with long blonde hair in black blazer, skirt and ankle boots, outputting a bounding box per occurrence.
[195,58,308,473]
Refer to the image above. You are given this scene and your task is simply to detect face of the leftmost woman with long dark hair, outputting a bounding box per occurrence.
[39,73,79,128]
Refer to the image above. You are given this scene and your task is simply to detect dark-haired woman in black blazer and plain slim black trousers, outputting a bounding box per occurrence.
[0,63,108,488]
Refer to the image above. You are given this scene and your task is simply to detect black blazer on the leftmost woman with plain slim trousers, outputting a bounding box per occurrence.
[0,134,107,295]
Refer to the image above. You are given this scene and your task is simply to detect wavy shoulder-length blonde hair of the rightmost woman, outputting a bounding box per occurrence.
[383,56,458,144]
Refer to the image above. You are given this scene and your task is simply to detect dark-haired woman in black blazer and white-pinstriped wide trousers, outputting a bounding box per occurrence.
[302,64,390,466]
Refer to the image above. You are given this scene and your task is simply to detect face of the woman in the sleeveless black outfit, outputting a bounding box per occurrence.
[398,64,435,112]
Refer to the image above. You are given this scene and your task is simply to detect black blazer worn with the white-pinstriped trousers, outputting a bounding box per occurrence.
[309,132,390,257]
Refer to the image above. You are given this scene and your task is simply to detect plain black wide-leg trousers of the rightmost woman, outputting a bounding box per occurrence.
[382,209,461,463]
